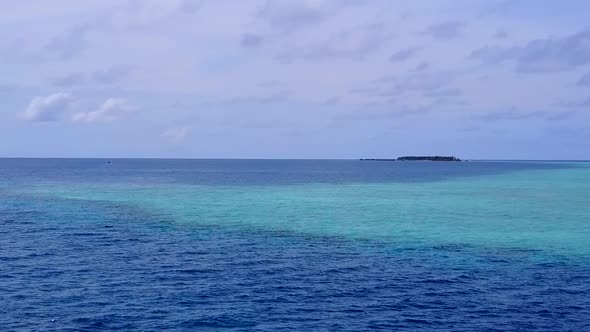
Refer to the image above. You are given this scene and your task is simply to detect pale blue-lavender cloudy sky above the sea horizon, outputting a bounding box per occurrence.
[0,0,590,159]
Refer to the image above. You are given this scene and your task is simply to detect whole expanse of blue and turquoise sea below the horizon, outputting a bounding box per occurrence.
[0,159,590,331]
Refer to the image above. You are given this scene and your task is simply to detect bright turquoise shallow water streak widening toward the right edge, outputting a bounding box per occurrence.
[20,163,590,256]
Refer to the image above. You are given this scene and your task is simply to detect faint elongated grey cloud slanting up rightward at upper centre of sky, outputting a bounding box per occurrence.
[277,24,392,62]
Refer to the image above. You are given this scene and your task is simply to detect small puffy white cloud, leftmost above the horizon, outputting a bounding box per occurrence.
[20,93,73,122]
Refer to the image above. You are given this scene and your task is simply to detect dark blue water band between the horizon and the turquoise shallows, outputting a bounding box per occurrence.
[0,159,569,186]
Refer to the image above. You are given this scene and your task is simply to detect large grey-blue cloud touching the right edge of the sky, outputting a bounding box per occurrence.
[469,29,590,73]
